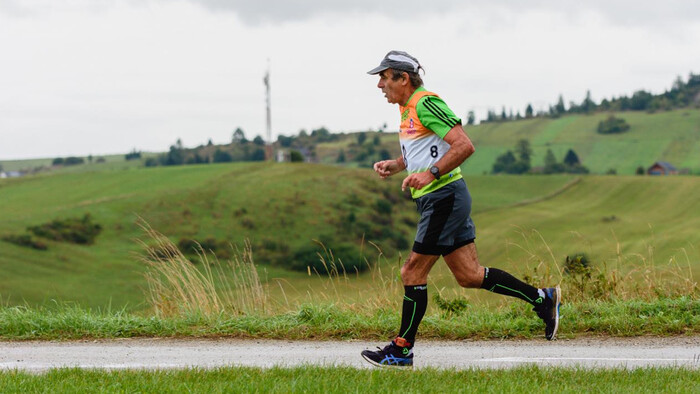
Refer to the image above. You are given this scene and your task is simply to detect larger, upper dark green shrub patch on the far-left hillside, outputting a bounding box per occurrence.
[27,213,102,245]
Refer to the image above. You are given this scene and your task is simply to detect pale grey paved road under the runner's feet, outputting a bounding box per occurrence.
[0,336,700,372]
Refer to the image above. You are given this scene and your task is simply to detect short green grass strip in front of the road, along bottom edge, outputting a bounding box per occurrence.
[0,366,700,393]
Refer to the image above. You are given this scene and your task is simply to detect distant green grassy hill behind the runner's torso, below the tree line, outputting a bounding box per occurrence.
[317,109,700,175]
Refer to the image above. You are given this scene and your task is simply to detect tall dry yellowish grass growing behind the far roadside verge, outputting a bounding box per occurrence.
[141,222,699,316]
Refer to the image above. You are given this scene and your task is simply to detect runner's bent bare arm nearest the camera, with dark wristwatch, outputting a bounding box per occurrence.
[401,124,475,190]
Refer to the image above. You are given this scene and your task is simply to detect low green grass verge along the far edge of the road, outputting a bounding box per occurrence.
[0,296,700,340]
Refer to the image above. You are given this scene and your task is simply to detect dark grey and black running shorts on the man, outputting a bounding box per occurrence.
[413,179,476,256]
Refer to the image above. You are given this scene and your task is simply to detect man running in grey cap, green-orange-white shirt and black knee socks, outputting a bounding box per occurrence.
[362,51,561,366]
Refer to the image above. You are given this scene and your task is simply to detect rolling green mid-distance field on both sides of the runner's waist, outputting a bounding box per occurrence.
[0,163,700,310]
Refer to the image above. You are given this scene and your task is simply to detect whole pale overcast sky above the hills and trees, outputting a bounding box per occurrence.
[0,0,700,161]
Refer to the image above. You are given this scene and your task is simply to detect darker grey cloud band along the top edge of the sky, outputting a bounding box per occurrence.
[0,0,700,28]
